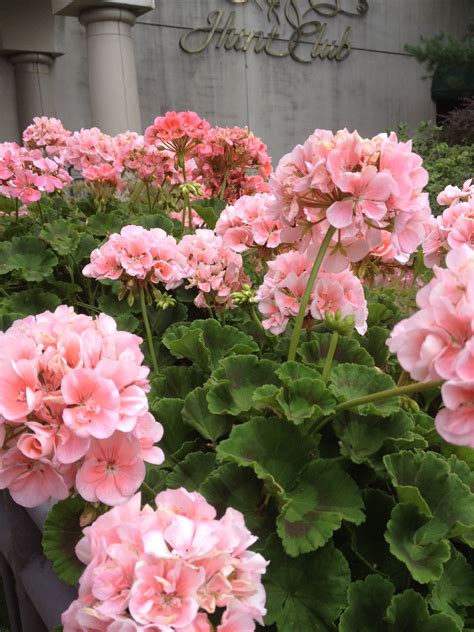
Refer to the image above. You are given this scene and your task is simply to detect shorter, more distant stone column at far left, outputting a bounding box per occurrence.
[9,52,56,130]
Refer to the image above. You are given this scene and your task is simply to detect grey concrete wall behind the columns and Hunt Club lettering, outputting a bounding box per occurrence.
[0,0,474,160]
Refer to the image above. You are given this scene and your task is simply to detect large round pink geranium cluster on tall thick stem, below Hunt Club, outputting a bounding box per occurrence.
[270,130,431,271]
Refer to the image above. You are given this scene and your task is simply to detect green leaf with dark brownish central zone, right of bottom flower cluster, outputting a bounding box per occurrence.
[277,459,365,557]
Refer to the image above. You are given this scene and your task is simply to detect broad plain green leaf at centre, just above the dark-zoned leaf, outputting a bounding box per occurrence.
[217,417,314,495]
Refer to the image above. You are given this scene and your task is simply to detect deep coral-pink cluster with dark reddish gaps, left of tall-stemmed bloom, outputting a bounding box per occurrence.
[196,127,272,203]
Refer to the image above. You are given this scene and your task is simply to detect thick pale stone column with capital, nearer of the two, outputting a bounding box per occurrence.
[79,6,141,135]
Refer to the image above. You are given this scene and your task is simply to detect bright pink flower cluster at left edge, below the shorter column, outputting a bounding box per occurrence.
[0,143,72,204]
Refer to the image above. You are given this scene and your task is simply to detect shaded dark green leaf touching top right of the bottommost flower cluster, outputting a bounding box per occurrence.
[199,463,273,532]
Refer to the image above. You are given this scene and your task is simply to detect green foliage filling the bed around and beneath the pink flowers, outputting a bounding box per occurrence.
[0,179,474,632]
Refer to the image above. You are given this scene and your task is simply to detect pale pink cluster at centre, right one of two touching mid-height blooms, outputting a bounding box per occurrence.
[178,229,249,309]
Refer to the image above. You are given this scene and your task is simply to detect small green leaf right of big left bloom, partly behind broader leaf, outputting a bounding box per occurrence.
[183,386,234,443]
